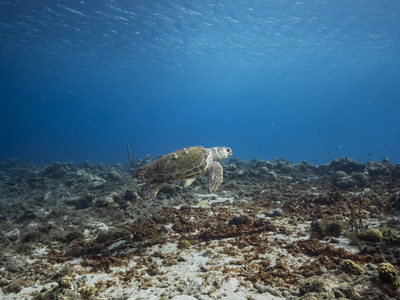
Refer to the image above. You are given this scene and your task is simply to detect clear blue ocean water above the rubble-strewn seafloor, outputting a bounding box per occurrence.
[0,0,400,165]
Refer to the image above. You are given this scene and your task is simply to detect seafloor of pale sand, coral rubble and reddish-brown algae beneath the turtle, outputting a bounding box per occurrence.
[0,157,400,300]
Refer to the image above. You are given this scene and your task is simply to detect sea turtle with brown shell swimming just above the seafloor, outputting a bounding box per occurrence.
[132,146,232,200]
